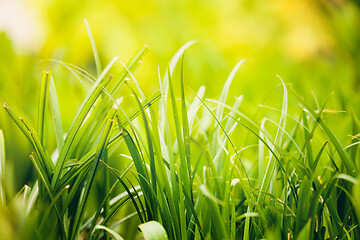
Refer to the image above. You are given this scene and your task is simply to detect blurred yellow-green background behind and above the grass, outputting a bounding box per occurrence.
[0,0,360,192]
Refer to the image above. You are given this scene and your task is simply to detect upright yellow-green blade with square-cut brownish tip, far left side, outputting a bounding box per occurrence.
[38,72,51,146]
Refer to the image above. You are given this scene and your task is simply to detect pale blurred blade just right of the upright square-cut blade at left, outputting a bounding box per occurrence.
[49,77,64,155]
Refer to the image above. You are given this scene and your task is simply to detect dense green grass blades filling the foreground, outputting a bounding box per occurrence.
[0,23,360,240]
